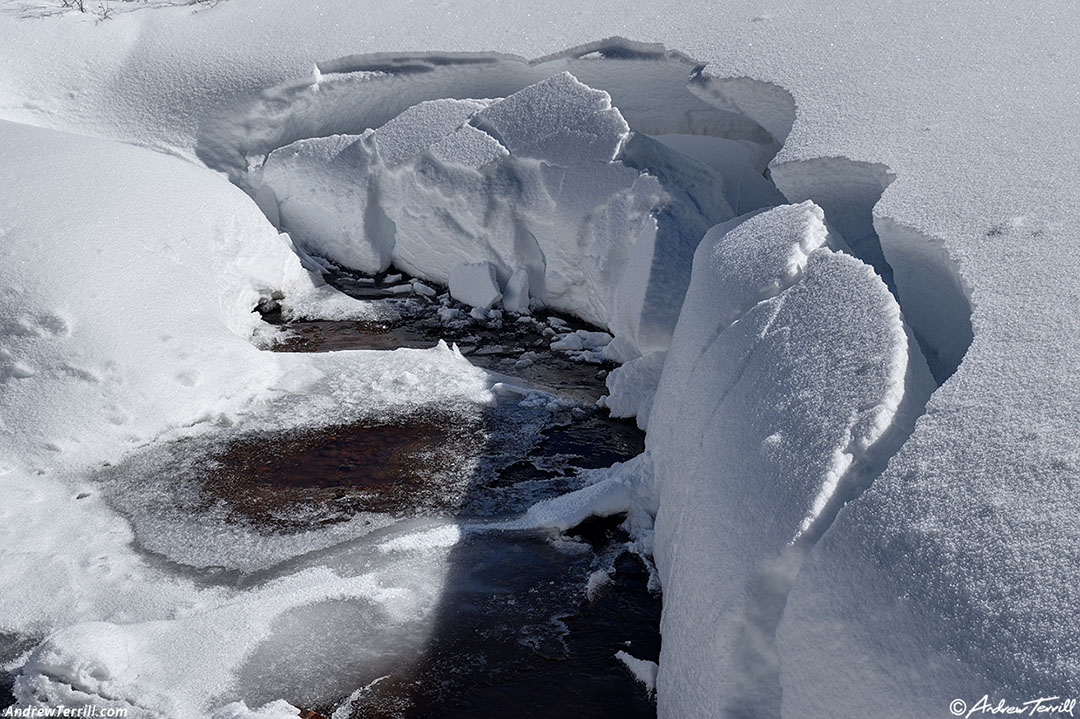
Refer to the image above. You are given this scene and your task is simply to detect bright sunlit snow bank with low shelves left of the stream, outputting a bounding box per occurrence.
[0,123,491,717]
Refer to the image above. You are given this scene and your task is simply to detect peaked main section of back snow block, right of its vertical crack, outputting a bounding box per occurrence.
[384,74,663,325]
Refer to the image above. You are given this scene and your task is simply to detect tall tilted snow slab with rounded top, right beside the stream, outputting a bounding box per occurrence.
[647,202,932,717]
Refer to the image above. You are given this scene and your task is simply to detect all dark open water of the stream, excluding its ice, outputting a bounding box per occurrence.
[257,264,660,719]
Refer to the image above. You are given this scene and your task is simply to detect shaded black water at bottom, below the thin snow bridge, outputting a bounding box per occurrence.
[325,526,660,719]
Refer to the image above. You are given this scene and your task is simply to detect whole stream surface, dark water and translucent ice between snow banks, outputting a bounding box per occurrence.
[2,265,660,718]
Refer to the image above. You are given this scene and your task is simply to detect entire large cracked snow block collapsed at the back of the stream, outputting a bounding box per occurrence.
[257,72,783,360]
